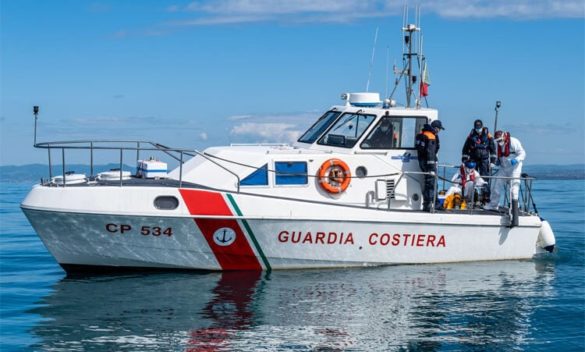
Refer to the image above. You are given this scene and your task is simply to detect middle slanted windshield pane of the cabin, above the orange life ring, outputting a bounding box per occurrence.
[318,113,376,148]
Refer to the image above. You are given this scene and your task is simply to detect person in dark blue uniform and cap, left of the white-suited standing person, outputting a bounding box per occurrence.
[461,119,496,202]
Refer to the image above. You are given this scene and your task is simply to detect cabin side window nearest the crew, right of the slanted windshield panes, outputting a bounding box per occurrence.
[360,116,427,149]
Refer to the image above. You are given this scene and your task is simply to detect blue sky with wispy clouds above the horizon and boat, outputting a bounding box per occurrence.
[0,0,585,165]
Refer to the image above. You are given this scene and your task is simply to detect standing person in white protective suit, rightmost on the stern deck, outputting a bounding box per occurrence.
[484,131,526,210]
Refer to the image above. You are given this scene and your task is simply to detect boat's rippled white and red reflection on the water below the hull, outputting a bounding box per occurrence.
[32,261,554,351]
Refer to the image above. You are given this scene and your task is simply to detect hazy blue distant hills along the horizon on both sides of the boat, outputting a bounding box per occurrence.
[0,164,585,182]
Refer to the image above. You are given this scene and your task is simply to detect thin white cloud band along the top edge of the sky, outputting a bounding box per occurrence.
[169,0,585,26]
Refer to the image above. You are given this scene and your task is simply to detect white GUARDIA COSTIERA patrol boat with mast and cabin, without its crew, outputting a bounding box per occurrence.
[21,25,555,272]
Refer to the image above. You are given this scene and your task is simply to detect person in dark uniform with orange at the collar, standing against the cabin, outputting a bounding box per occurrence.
[416,120,445,211]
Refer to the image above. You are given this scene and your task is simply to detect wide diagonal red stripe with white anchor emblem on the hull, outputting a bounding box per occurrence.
[180,189,262,270]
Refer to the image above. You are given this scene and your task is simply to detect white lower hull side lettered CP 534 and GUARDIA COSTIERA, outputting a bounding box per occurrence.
[23,208,542,270]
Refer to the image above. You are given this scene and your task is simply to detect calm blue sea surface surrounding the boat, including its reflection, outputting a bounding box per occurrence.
[0,180,585,351]
